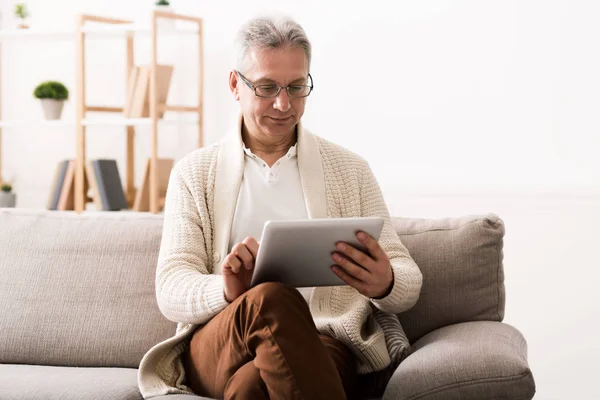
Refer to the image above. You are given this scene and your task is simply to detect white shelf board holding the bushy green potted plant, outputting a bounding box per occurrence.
[0,117,198,128]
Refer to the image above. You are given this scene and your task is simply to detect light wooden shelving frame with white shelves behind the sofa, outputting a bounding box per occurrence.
[0,9,204,213]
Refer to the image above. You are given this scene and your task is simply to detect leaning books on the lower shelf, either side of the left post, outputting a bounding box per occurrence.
[47,160,129,211]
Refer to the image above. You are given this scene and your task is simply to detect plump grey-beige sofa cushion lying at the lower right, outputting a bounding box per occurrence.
[383,321,535,400]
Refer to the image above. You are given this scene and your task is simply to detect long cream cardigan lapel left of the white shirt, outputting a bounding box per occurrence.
[213,115,244,273]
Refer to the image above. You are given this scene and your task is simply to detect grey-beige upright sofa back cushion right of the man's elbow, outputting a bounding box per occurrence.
[393,214,505,343]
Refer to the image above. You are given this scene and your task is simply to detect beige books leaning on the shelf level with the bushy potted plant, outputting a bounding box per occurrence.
[123,64,173,118]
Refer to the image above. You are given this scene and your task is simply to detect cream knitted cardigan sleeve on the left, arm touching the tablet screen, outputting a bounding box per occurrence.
[156,166,228,324]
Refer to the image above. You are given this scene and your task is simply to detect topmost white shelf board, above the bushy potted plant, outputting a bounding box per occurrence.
[0,21,198,41]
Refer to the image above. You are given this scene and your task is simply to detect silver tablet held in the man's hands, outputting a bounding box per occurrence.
[250,217,383,287]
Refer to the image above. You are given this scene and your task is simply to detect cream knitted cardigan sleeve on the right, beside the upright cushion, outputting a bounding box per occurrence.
[360,161,423,314]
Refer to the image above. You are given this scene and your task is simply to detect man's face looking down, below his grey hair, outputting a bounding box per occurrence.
[230,47,309,139]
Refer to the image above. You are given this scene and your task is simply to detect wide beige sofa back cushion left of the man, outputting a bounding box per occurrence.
[0,209,176,367]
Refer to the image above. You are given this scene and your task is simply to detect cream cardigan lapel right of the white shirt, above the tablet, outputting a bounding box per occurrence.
[298,123,327,219]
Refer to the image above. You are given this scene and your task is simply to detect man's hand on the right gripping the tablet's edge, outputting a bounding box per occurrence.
[331,232,394,298]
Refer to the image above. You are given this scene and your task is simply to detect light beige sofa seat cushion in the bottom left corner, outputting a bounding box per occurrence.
[0,364,142,400]
